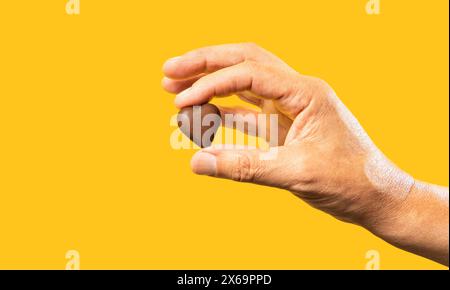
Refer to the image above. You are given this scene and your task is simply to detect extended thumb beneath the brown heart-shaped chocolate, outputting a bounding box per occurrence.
[191,147,285,187]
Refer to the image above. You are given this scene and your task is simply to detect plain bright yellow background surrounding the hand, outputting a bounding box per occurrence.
[0,0,449,269]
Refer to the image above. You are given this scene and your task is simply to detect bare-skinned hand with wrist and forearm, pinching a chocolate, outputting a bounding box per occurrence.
[163,43,449,266]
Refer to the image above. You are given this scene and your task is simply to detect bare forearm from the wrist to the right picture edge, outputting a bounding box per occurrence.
[373,181,449,266]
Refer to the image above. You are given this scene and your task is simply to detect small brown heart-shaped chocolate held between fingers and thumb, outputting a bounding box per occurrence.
[177,104,222,148]
